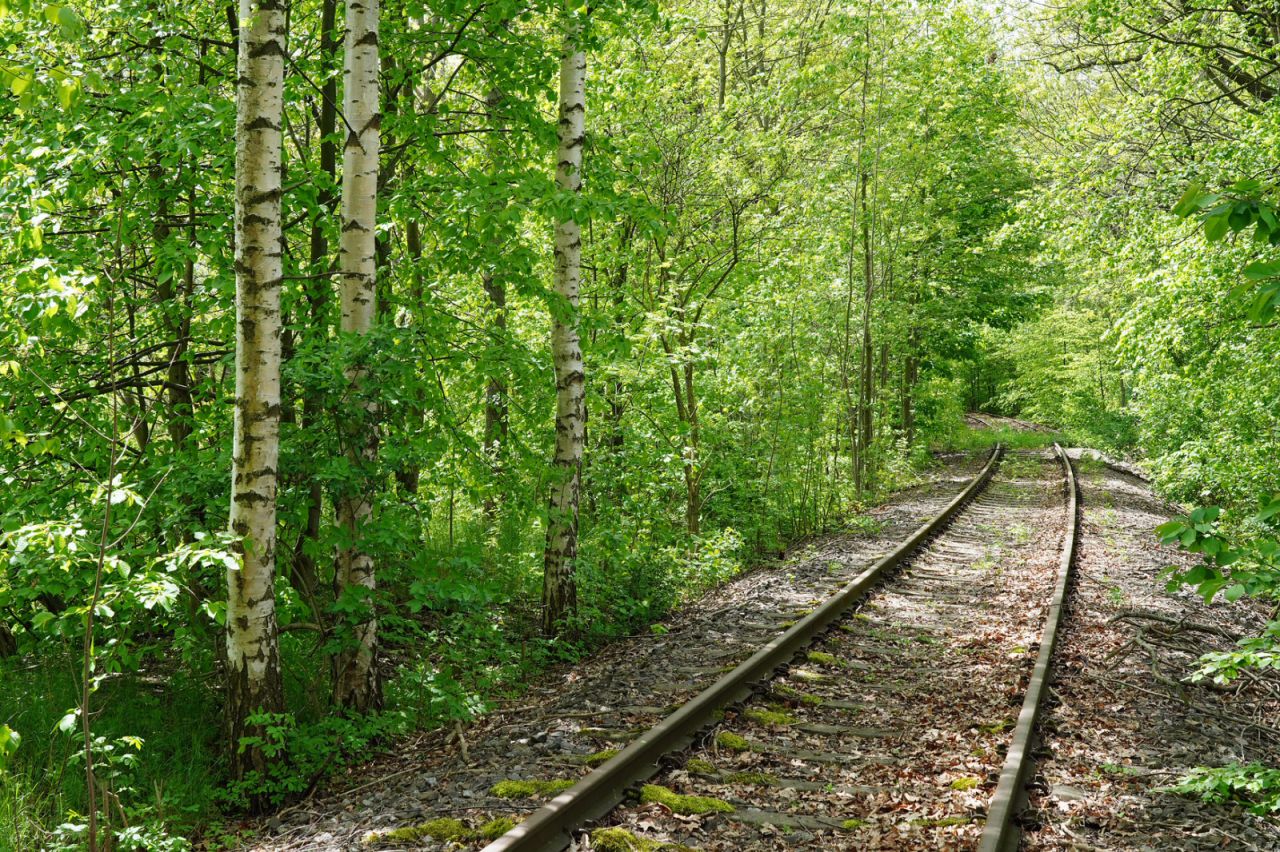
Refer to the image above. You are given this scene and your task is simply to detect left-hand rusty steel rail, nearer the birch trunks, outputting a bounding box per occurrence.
[483,444,1004,852]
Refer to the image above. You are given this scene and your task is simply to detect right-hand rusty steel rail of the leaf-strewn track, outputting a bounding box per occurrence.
[978,444,1079,852]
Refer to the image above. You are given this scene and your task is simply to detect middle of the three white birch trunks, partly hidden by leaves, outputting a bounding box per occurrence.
[333,0,381,711]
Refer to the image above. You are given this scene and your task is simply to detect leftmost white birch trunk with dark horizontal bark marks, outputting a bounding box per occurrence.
[227,0,287,788]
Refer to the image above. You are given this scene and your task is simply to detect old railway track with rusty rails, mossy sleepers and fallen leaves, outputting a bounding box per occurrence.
[485,446,1076,852]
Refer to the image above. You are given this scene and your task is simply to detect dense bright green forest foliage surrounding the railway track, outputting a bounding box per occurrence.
[0,0,1280,848]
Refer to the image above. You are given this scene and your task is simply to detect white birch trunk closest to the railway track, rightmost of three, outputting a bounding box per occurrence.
[543,19,586,635]
